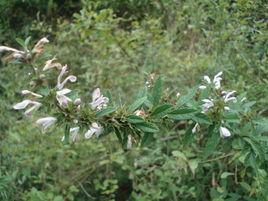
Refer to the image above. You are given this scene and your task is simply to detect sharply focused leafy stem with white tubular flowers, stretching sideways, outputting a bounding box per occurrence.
[0,38,268,157]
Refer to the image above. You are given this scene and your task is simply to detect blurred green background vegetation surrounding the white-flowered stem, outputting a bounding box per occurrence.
[0,0,268,201]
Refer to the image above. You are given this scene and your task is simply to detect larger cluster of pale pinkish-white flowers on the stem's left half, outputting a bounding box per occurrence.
[10,38,109,142]
